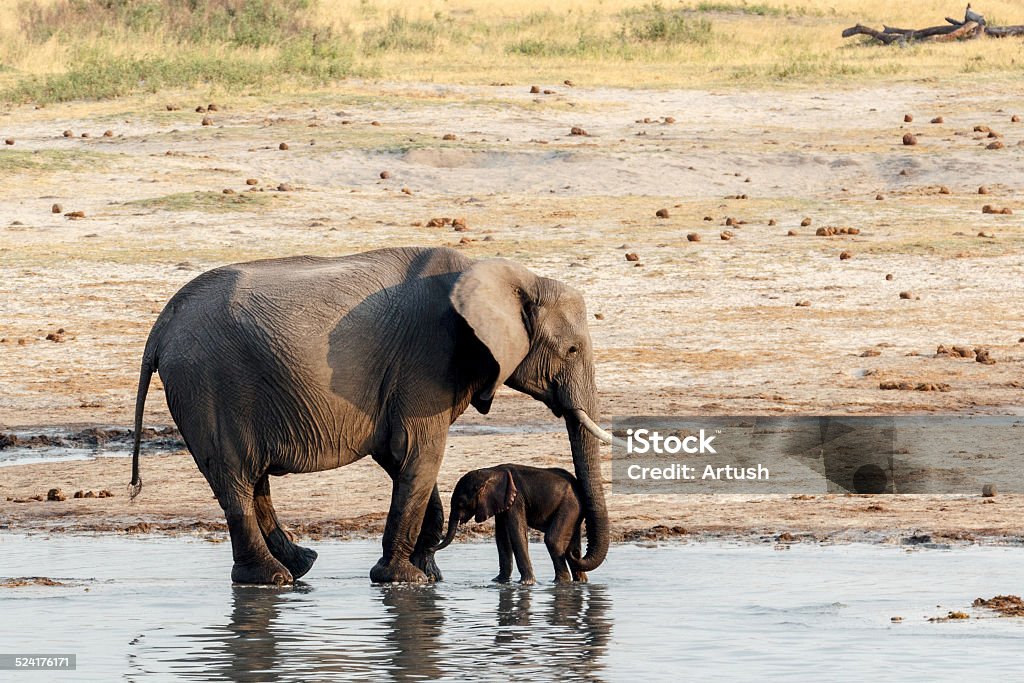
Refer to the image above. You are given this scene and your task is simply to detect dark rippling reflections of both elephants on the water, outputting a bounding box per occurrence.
[202,584,612,682]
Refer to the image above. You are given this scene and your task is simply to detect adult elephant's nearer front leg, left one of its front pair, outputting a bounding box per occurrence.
[370,443,443,584]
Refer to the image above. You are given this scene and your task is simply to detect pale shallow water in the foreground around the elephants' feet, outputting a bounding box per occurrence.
[0,536,1024,681]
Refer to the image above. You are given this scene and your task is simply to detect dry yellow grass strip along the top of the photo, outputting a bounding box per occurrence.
[0,0,1024,96]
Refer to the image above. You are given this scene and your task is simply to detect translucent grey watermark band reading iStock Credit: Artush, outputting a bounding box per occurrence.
[611,415,1024,495]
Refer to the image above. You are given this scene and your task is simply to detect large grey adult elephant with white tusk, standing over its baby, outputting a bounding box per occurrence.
[126,242,608,584]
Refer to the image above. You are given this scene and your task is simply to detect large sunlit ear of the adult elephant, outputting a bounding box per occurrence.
[450,258,537,415]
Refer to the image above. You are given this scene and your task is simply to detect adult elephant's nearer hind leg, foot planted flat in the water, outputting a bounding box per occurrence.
[219,487,294,586]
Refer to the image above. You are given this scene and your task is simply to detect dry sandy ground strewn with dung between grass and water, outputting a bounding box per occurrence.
[0,83,1024,539]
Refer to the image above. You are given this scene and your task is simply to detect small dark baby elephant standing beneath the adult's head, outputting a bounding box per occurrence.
[434,465,587,585]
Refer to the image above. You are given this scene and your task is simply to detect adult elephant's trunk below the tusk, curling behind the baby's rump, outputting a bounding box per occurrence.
[565,408,610,571]
